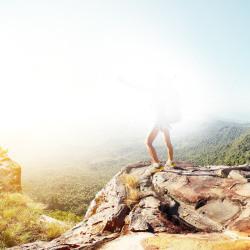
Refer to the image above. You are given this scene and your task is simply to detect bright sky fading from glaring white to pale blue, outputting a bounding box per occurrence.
[0,0,250,132]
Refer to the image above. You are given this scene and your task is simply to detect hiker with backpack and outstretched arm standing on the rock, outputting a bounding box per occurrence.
[118,73,180,173]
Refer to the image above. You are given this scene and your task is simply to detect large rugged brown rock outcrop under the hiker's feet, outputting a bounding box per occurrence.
[13,161,250,249]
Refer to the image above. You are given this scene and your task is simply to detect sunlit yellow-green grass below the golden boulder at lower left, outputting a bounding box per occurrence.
[0,193,73,249]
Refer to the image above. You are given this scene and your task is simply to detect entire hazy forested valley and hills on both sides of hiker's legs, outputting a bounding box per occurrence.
[23,121,250,219]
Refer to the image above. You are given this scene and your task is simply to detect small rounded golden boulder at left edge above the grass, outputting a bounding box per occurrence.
[0,157,22,192]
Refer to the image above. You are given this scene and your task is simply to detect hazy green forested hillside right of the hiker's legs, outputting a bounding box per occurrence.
[175,121,250,166]
